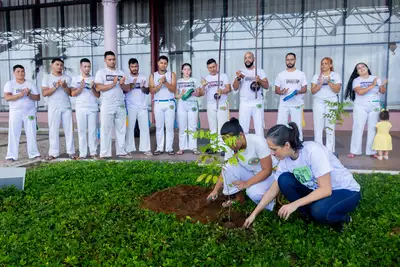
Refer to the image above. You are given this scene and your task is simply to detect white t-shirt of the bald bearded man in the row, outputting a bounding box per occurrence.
[232,68,267,102]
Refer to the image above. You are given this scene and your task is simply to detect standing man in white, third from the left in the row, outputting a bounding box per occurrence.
[71,58,100,159]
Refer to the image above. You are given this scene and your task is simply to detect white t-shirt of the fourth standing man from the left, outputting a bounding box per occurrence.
[94,68,125,105]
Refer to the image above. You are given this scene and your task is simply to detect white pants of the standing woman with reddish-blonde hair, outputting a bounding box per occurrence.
[313,96,337,152]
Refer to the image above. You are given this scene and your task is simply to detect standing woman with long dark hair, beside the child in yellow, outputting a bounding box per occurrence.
[345,63,387,158]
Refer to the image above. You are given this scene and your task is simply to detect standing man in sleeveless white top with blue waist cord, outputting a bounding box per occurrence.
[149,56,176,155]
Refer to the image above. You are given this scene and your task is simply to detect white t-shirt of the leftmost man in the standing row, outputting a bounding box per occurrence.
[4,80,40,112]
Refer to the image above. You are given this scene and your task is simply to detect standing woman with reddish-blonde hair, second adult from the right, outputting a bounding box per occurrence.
[311,57,342,152]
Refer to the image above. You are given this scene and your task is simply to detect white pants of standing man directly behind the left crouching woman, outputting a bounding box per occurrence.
[207,101,229,150]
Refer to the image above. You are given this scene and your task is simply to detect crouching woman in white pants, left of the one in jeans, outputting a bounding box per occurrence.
[207,118,275,213]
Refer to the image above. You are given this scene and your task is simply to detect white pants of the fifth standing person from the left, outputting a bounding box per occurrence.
[125,107,150,152]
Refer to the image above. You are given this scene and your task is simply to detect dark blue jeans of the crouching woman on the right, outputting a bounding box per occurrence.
[278,172,361,225]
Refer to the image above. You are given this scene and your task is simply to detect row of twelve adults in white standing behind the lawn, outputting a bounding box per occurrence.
[4,51,386,161]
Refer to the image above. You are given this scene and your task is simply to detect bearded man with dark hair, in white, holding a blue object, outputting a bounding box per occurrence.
[275,53,307,140]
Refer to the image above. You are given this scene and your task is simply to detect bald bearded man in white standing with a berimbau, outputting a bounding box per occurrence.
[232,52,269,137]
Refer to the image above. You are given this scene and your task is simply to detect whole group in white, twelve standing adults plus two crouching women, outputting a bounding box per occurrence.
[4,51,391,230]
